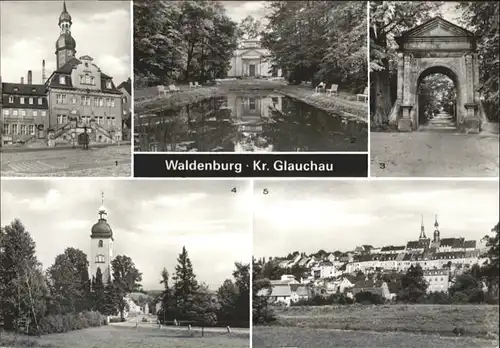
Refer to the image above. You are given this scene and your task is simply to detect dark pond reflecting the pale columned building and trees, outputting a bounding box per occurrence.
[135,93,368,152]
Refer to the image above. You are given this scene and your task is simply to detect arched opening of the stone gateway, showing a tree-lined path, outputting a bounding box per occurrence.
[414,66,463,129]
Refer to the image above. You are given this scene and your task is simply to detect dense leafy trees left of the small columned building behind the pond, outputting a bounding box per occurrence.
[134,0,237,85]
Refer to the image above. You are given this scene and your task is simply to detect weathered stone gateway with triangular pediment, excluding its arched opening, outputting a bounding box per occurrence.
[390,17,485,133]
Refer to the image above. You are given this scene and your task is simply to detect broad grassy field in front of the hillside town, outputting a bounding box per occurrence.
[252,305,498,348]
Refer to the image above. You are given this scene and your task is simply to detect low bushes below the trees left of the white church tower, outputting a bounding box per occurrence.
[39,312,106,334]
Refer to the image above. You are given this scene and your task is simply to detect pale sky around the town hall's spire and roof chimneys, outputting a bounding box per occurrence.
[0,0,132,85]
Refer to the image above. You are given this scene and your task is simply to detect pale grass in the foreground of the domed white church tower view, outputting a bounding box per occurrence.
[0,326,249,348]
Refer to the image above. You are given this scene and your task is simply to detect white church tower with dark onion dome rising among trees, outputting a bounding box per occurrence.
[89,193,113,283]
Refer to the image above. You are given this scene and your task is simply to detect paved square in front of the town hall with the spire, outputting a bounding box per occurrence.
[0,145,131,177]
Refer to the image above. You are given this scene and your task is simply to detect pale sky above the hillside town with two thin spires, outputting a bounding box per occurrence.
[254,180,499,258]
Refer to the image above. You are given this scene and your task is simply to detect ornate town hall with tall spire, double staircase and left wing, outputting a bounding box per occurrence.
[1,2,124,146]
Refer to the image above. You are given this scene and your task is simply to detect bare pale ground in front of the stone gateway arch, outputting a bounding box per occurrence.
[370,132,499,177]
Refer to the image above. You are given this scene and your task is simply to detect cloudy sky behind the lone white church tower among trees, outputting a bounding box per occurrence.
[1,179,252,290]
